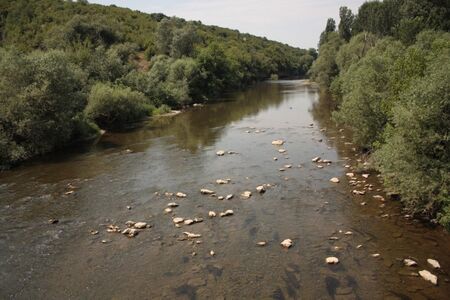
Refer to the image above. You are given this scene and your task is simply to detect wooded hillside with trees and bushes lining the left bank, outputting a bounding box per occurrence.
[0,0,317,166]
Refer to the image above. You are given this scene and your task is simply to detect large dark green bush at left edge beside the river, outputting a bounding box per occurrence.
[0,50,86,164]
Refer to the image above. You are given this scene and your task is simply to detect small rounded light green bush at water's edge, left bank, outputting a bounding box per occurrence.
[84,83,151,128]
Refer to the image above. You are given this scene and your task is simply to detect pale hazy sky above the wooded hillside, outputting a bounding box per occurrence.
[89,0,365,48]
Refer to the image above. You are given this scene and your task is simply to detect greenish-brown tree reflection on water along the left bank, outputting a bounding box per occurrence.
[104,83,284,152]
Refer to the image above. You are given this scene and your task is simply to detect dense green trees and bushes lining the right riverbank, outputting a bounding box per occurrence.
[310,0,450,229]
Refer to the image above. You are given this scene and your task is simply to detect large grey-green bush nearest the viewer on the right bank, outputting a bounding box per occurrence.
[375,51,450,229]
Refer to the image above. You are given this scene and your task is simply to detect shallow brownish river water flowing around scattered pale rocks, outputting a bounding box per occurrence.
[0,81,450,299]
